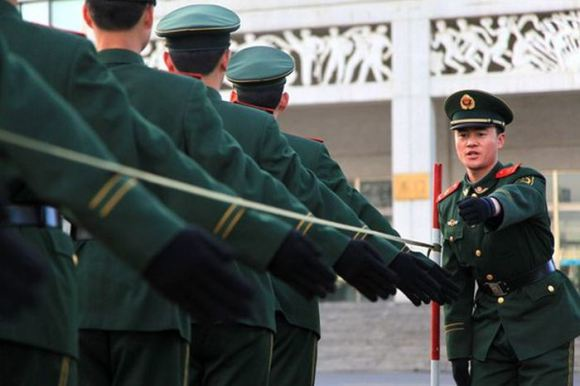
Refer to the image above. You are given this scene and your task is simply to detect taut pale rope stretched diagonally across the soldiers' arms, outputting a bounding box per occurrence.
[0,129,437,249]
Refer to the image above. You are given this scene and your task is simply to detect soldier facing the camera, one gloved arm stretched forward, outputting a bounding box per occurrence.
[438,90,580,386]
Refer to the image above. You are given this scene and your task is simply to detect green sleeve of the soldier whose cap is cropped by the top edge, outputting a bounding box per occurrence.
[183,92,349,260]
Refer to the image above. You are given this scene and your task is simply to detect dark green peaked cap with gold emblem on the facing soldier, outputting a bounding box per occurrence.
[445,90,514,130]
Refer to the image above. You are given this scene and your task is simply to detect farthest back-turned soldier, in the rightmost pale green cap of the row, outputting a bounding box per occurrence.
[226,46,454,386]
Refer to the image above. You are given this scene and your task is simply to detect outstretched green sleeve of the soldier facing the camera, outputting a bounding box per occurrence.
[489,169,546,230]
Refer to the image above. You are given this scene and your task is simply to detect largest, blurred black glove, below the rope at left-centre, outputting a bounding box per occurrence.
[143,227,253,322]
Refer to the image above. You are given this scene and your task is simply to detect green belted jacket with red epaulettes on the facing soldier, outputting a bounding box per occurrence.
[439,163,580,361]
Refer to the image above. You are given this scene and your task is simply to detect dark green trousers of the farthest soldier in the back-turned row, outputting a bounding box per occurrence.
[270,314,318,386]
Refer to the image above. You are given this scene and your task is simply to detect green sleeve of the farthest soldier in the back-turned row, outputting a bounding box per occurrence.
[316,146,404,250]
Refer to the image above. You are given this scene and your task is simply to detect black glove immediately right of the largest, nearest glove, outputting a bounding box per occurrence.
[268,230,336,299]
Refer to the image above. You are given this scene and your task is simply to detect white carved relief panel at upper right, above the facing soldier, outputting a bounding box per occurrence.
[431,11,580,76]
